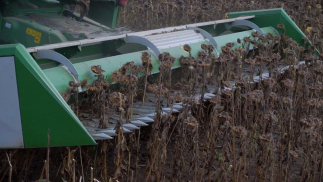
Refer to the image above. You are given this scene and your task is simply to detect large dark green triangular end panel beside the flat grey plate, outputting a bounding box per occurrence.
[0,44,96,148]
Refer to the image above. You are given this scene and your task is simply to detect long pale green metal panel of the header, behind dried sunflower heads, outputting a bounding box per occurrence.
[43,27,277,93]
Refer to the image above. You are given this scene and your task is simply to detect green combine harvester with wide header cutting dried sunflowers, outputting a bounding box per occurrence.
[0,0,314,148]
